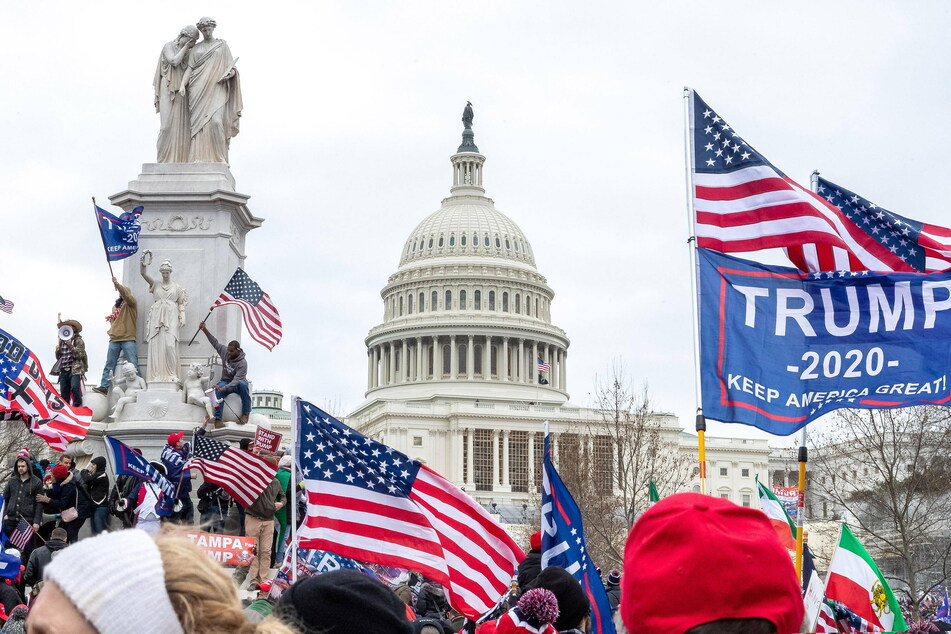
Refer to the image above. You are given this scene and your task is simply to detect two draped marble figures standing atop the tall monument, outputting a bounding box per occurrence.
[154,18,242,163]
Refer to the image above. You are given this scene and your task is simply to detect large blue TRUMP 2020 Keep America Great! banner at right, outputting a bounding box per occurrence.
[697,249,951,435]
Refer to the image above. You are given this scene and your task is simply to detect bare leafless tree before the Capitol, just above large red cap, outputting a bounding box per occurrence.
[555,360,692,569]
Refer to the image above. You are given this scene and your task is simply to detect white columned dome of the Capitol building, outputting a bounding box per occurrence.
[366,110,569,403]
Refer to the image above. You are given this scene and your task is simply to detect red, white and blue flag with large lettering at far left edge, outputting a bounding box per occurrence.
[0,330,92,449]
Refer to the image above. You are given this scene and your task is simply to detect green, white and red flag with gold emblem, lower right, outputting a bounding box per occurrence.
[826,524,908,632]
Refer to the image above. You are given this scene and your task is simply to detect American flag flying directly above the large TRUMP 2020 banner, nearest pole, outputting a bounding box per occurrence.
[689,91,914,271]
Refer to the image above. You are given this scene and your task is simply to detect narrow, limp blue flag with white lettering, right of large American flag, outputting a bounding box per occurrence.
[542,424,616,634]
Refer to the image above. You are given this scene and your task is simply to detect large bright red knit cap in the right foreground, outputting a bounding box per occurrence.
[620,493,804,634]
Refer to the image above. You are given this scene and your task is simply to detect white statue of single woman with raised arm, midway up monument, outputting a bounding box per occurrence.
[139,251,188,384]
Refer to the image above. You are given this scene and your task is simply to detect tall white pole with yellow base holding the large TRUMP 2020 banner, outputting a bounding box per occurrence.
[684,87,707,493]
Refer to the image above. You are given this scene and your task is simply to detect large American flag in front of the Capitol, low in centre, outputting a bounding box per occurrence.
[294,400,525,619]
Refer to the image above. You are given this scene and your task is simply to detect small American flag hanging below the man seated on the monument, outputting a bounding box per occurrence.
[185,435,277,508]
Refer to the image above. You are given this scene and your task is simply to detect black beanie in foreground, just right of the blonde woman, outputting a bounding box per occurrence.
[276,570,413,634]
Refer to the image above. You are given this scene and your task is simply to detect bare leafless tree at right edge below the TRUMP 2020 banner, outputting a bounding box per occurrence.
[809,407,951,610]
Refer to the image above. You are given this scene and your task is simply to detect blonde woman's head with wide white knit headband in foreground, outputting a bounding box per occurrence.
[27,529,293,634]
